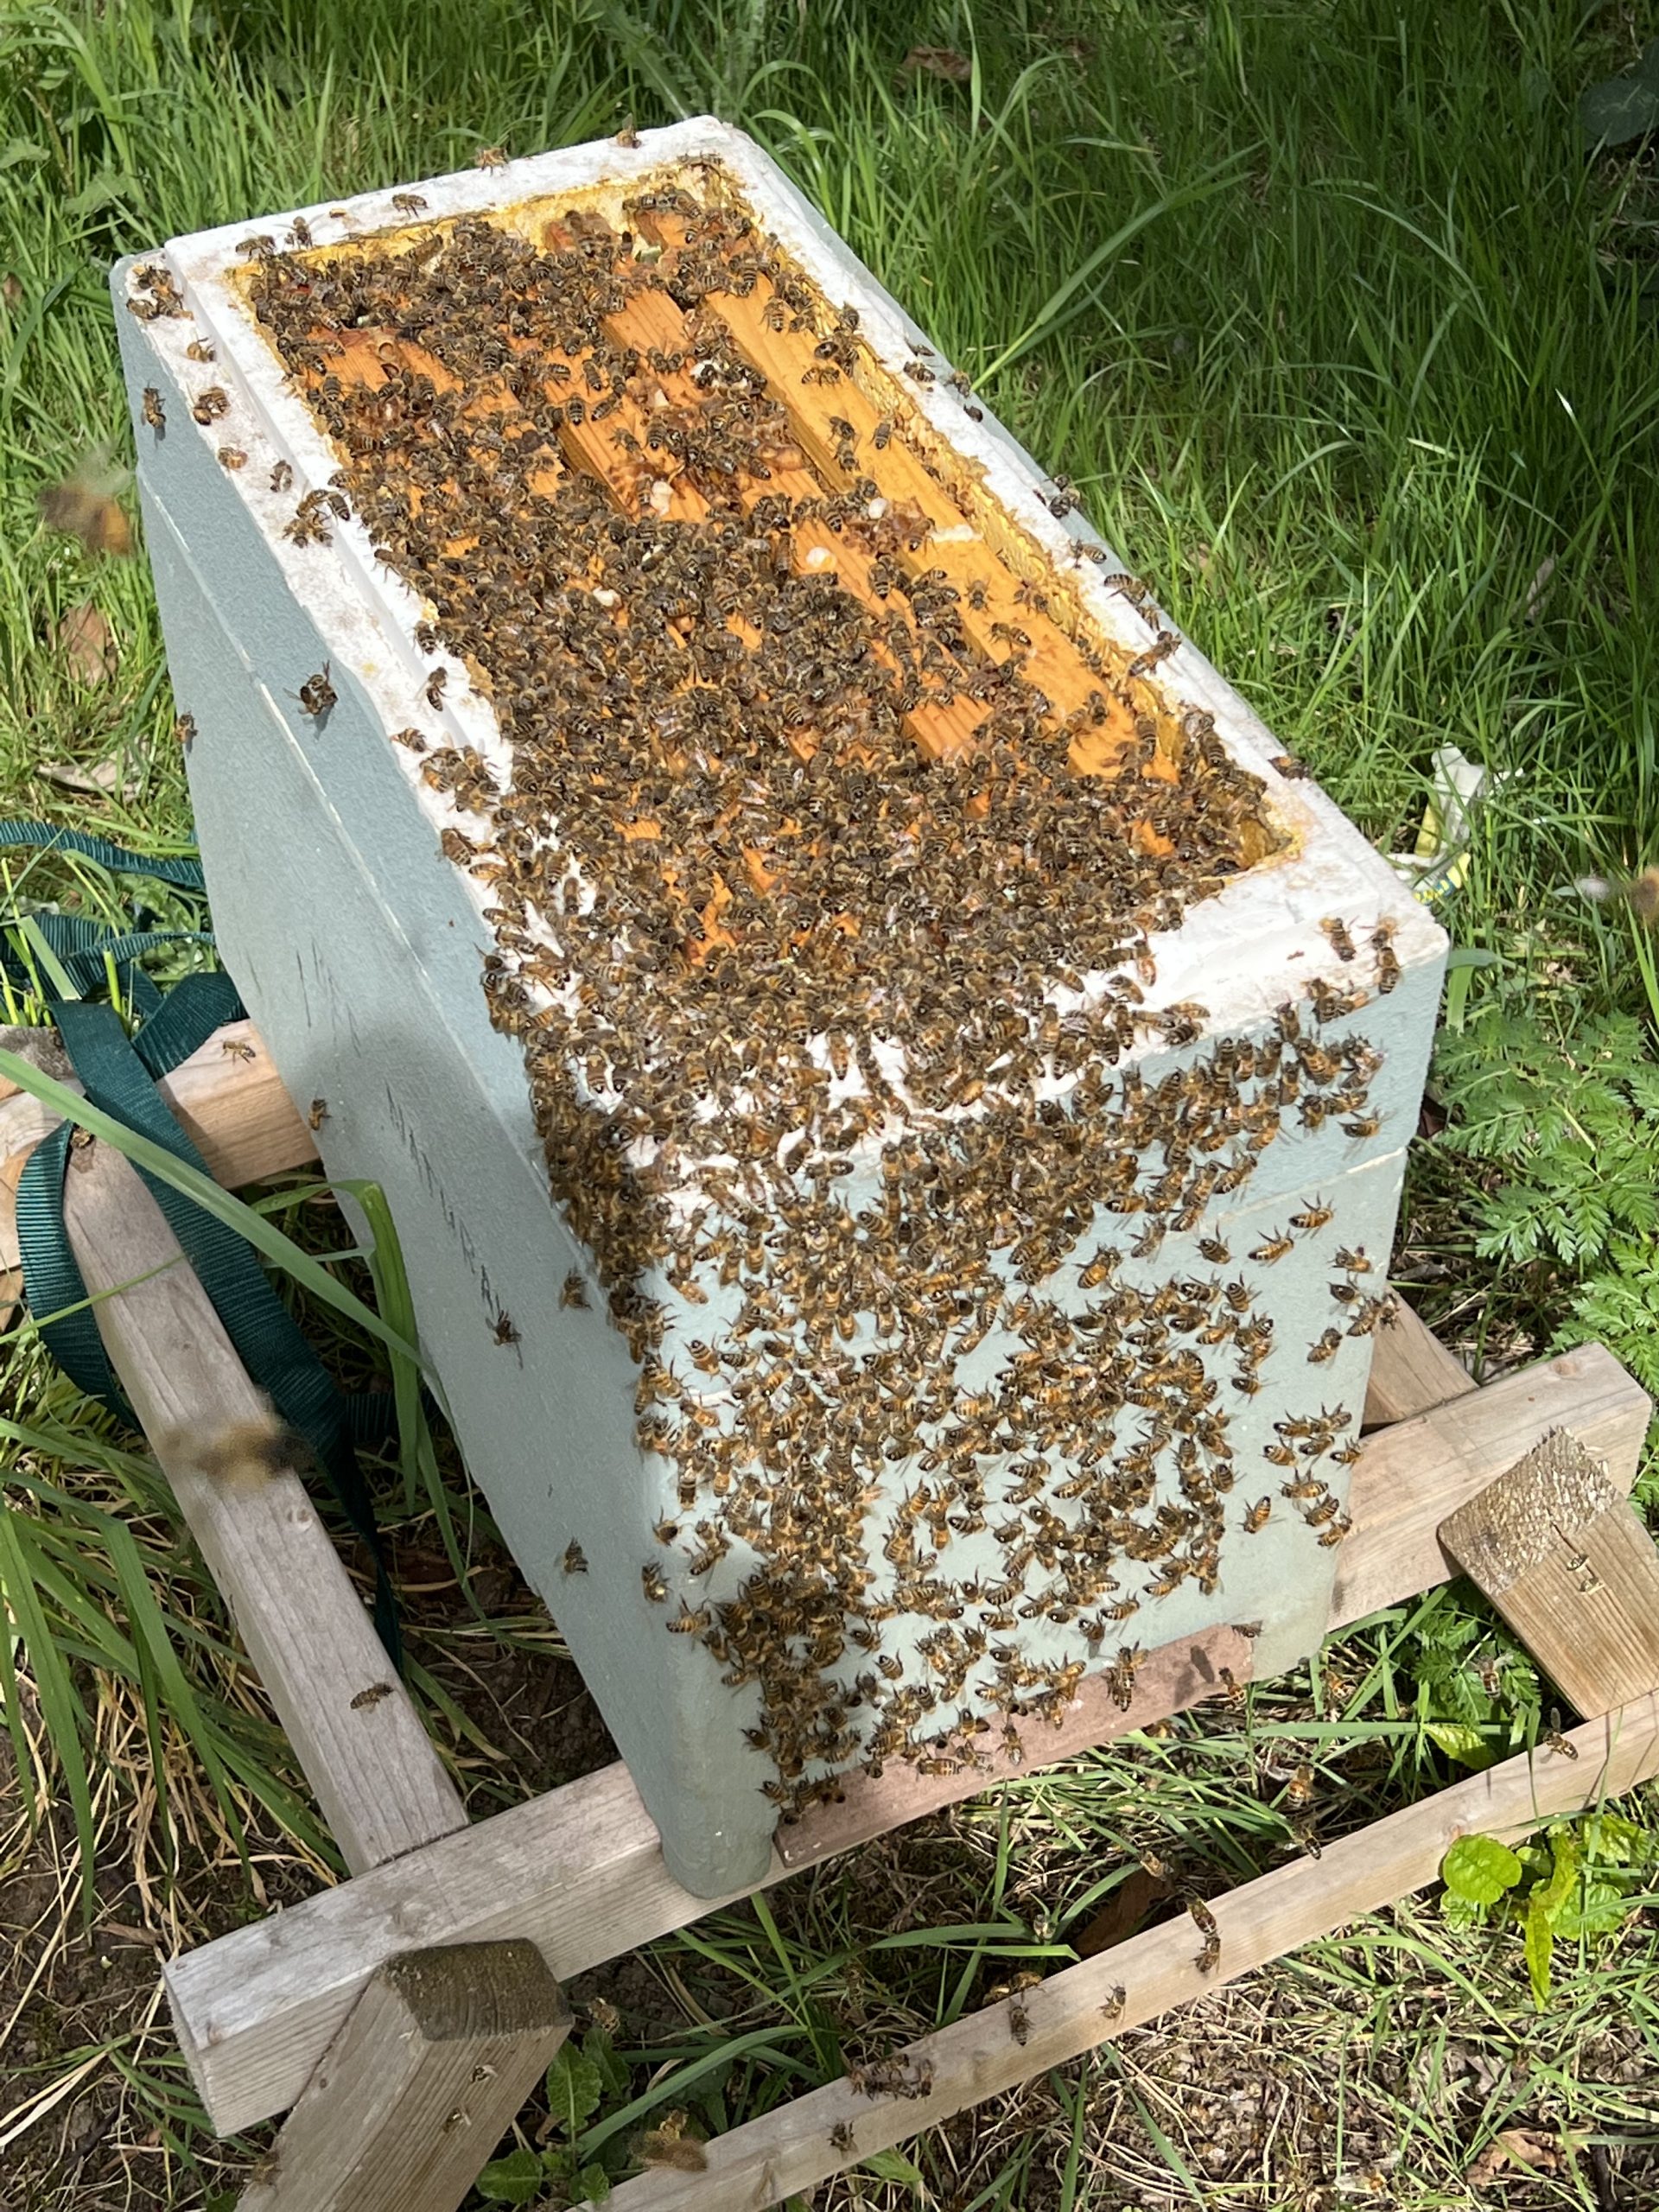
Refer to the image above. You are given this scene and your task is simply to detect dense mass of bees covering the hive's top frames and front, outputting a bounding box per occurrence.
[239,188,1398,1814]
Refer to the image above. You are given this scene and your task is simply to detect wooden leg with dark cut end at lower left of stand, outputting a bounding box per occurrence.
[238,1942,570,2212]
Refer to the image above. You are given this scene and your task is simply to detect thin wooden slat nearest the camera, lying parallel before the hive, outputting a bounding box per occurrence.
[611,1697,1659,2212]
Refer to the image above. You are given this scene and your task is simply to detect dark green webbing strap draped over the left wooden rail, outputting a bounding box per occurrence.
[0,821,403,1668]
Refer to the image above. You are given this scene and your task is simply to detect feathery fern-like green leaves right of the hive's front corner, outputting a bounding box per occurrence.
[1435,1000,1659,1389]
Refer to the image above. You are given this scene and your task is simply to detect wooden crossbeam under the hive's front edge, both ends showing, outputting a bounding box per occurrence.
[166,1347,1648,2133]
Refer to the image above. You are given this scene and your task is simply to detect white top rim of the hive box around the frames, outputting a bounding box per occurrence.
[146,118,1445,1144]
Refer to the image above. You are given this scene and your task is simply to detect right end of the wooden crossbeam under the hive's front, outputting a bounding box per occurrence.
[1332,1344,1650,1630]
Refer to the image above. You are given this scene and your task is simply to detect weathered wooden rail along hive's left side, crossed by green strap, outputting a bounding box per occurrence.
[64,1144,467,1885]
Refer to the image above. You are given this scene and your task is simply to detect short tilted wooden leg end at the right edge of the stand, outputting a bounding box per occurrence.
[1440,1431,1659,1719]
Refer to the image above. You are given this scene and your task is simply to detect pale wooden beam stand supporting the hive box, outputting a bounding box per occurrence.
[0,1024,1659,2212]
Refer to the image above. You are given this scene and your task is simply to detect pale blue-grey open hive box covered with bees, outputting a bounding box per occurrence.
[115,122,1442,1896]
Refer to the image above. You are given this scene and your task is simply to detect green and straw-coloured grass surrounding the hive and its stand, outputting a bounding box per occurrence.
[0,0,1659,2212]
